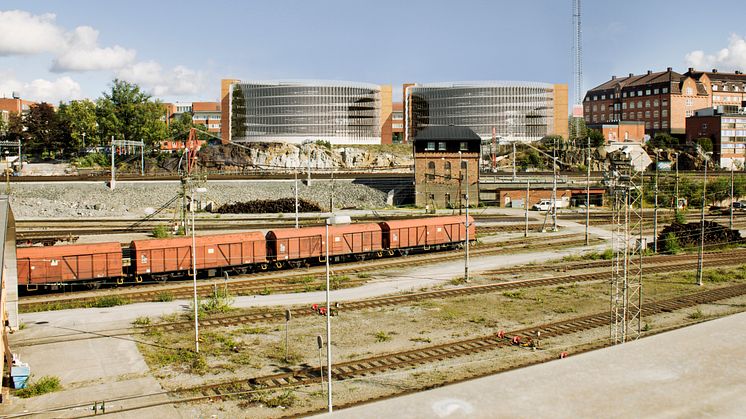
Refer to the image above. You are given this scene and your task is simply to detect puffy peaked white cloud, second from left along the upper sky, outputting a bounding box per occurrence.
[52,26,136,72]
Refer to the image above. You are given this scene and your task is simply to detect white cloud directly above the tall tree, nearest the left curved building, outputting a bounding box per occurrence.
[116,61,205,97]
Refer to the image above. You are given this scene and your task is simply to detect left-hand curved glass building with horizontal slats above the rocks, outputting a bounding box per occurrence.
[229,80,384,144]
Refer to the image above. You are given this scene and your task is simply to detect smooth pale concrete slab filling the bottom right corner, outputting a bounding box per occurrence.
[323,313,746,419]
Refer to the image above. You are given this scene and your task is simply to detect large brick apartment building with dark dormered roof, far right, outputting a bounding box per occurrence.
[583,67,746,136]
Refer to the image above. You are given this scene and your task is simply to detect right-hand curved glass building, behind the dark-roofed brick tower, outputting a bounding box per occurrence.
[405,81,567,141]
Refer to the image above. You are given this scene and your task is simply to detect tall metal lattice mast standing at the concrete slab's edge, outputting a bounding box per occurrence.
[609,159,645,344]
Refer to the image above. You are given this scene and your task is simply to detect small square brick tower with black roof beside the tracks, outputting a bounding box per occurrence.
[414,126,481,210]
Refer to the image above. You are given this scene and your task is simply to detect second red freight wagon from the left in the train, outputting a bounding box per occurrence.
[130,231,267,276]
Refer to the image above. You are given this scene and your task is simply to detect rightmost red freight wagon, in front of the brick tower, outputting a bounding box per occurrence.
[380,216,477,250]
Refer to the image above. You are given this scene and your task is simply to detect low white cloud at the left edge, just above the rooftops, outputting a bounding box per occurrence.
[0,72,83,104]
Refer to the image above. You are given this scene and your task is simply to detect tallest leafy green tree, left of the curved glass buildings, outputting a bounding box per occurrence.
[96,79,167,145]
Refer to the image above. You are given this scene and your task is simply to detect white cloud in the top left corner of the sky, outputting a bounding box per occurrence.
[0,10,65,56]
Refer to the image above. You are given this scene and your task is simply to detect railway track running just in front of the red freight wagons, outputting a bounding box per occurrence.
[19,235,584,312]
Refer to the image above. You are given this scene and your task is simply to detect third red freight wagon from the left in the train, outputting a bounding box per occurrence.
[267,223,383,265]
